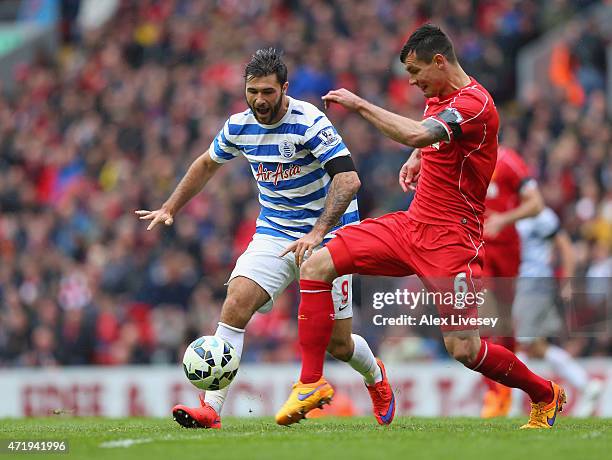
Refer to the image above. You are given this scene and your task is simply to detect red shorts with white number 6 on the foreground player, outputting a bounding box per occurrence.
[326,211,484,331]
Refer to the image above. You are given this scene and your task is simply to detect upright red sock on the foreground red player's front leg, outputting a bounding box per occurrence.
[298,280,334,383]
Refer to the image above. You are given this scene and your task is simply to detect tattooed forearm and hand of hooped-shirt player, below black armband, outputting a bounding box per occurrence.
[281,171,361,266]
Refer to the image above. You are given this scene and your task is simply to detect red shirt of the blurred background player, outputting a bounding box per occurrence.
[485,146,532,245]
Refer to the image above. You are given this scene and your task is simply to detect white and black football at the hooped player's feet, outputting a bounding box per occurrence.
[183,335,239,390]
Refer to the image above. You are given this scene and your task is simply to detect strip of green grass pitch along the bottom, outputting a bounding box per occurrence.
[0,416,612,460]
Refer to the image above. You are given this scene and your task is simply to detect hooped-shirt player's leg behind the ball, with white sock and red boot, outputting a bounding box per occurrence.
[172,276,270,428]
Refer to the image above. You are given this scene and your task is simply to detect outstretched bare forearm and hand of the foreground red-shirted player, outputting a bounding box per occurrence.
[323,88,449,147]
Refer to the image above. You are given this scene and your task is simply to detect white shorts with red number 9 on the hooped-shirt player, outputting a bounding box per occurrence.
[227,233,353,319]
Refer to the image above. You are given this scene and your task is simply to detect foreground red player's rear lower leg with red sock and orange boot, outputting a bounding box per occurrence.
[444,331,566,428]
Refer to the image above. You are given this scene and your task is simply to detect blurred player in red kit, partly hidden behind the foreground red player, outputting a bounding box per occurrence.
[481,146,544,418]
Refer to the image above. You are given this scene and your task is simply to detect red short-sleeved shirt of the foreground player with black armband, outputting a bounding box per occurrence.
[409,79,499,238]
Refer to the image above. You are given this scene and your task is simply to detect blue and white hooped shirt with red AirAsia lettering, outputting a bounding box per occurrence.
[209,98,359,240]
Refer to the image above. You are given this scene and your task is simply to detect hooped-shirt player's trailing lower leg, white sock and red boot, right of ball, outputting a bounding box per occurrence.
[327,318,395,425]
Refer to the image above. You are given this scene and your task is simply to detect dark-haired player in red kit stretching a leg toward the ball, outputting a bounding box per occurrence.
[276,24,565,428]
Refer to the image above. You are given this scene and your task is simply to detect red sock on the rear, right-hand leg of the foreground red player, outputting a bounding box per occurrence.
[469,339,553,402]
